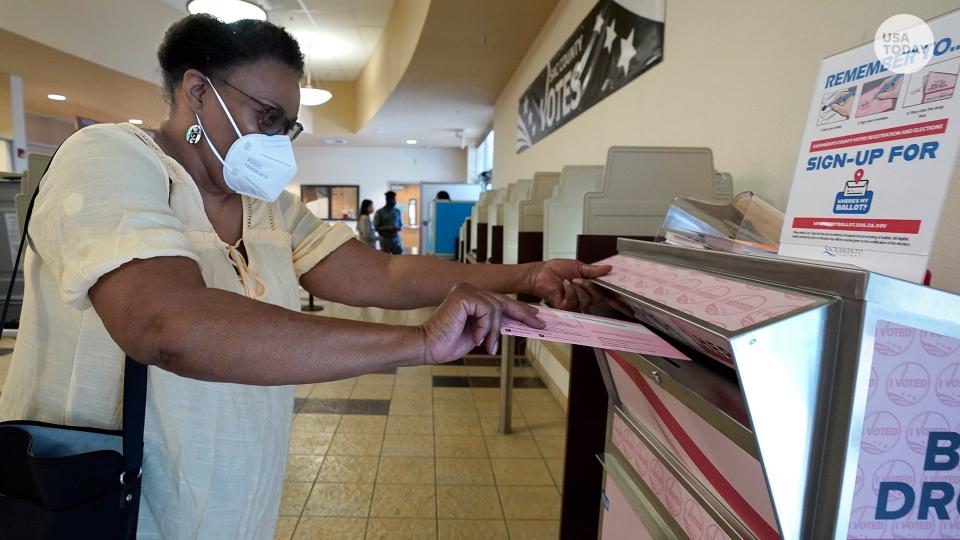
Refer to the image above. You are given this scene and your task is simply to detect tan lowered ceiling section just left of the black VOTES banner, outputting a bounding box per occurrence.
[360,0,557,146]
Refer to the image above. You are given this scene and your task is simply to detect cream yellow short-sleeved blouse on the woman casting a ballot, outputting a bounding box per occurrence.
[0,124,353,539]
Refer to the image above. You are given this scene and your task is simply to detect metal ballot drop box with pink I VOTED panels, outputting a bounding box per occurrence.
[584,239,960,540]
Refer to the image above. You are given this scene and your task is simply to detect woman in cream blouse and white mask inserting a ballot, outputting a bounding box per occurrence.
[0,16,609,539]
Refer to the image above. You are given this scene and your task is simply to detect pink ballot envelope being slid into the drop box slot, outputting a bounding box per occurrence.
[500,306,690,360]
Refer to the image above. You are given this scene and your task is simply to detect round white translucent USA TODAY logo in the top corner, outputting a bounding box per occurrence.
[873,13,933,75]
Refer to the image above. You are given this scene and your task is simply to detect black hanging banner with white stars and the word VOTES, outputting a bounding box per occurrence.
[517,0,665,153]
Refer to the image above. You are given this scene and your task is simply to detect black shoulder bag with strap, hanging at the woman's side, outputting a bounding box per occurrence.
[0,153,147,540]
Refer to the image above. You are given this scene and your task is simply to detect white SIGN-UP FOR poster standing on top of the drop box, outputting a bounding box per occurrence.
[780,11,960,283]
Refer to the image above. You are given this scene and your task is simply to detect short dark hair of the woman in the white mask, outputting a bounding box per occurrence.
[157,14,303,103]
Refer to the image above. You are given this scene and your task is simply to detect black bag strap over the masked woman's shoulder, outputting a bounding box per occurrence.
[0,147,147,507]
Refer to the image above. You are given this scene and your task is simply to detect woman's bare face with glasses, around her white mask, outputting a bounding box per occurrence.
[184,60,300,188]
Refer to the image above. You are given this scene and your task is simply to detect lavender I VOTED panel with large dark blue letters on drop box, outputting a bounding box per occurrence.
[847,320,960,539]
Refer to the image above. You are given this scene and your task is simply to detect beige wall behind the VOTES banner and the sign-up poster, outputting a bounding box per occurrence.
[494,0,960,291]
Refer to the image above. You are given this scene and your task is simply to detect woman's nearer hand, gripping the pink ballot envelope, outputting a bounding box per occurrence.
[420,283,544,364]
